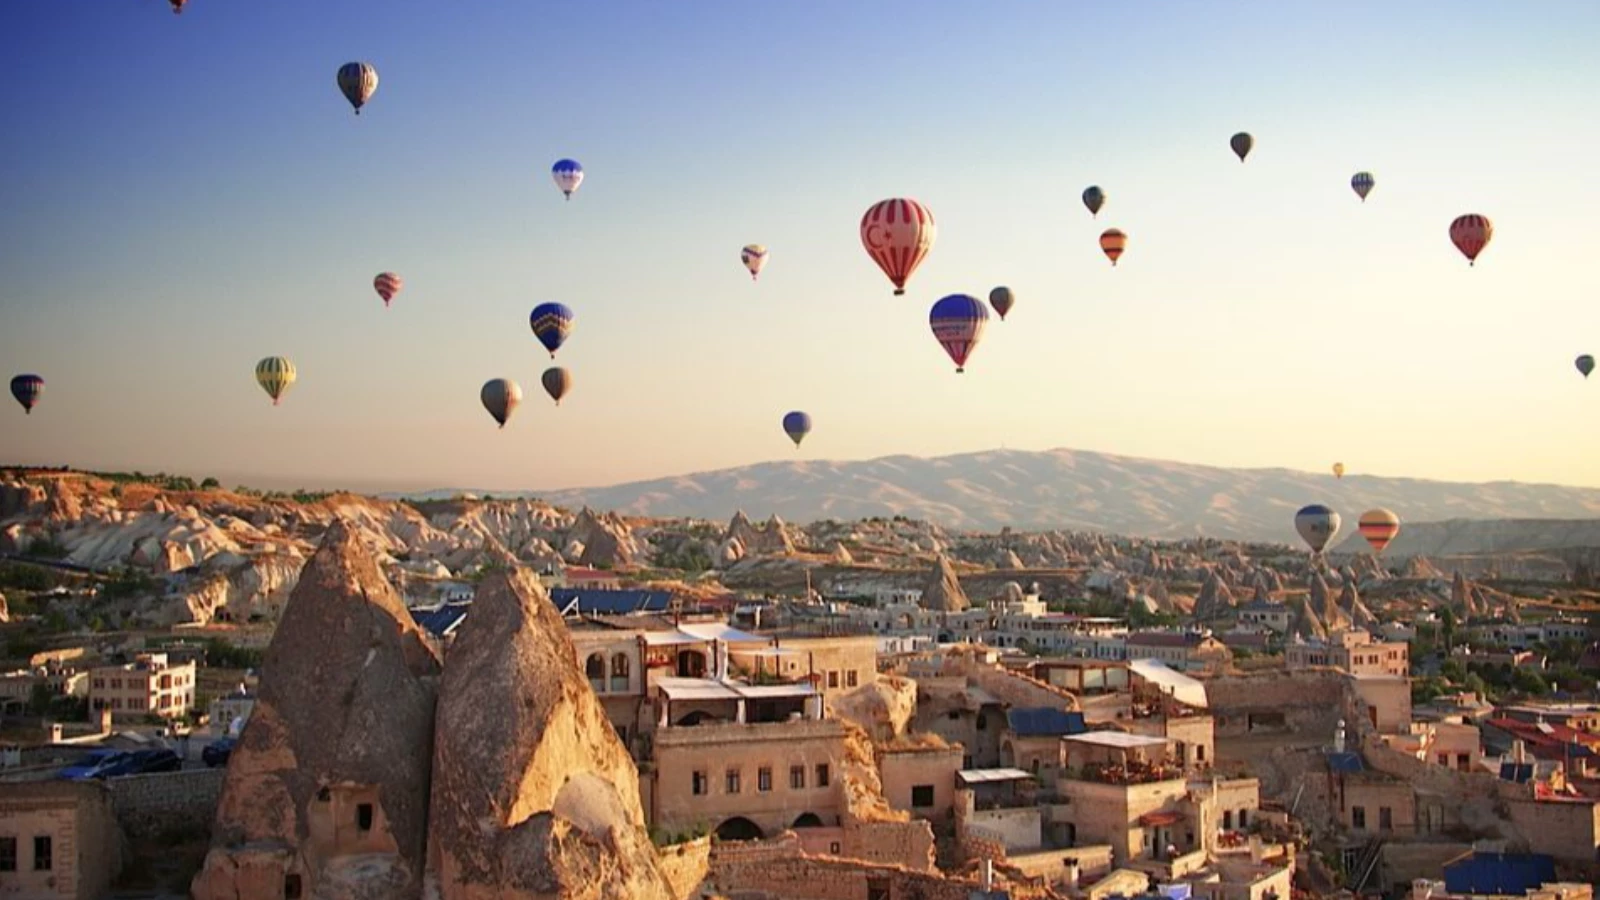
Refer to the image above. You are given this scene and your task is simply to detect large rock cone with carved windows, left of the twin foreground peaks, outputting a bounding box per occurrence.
[192,522,438,900]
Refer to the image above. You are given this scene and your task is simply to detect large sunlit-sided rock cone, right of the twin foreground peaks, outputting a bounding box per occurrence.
[427,569,675,900]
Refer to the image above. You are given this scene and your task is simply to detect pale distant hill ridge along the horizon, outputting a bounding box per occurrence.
[508,450,1600,538]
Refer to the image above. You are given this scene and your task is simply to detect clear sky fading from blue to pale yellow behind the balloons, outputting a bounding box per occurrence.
[0,0,1600,490]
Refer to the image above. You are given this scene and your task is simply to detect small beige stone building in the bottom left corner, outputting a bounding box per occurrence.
[0,781,122,900]
